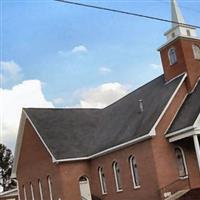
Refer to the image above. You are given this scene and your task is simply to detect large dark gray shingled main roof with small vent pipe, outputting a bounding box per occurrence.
[24,76,183,159]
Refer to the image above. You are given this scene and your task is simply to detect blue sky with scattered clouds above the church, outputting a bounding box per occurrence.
[0,0,200,148]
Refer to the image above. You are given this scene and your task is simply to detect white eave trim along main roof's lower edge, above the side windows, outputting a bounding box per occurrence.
[54,134,152,163]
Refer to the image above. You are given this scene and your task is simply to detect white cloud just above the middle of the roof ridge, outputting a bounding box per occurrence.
[76,82,129,108]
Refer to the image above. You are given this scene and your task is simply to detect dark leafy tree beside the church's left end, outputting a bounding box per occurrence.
[0,144,16,191]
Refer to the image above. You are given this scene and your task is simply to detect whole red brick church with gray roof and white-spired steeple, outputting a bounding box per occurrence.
[12,0,200,200]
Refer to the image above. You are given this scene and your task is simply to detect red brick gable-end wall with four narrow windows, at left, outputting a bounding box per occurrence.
[17,121,61,200]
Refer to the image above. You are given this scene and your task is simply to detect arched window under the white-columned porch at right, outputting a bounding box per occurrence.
[175,147,188,178]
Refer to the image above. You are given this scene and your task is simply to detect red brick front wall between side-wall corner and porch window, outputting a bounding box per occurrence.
[152,81,187,188]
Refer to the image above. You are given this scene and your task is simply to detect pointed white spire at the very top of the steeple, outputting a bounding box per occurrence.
[171,0,185,27]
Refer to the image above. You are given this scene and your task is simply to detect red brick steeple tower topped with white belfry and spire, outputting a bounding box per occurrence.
[159,0,200,90]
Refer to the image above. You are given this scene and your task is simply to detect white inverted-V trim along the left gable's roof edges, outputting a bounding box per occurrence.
[11,110,55,178]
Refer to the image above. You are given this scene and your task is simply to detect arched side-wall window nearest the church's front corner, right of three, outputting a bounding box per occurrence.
[129,156,140,188]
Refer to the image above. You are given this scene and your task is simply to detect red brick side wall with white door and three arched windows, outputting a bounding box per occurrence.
[54,141,159,200]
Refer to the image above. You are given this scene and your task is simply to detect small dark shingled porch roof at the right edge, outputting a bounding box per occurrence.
[168,83,200,133]
